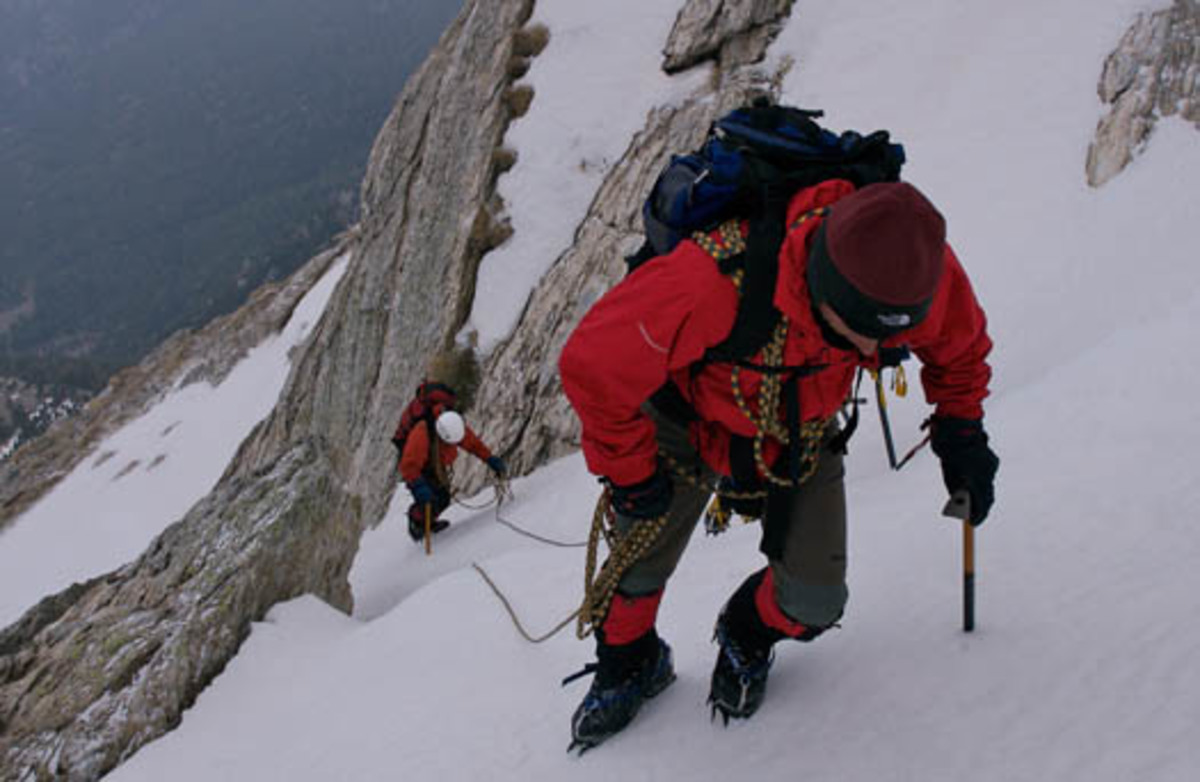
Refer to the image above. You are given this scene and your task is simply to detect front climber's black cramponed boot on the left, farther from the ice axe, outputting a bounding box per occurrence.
[563,630,674,754]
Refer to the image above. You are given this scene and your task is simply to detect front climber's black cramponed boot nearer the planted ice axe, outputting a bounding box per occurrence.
[708,571,787,724]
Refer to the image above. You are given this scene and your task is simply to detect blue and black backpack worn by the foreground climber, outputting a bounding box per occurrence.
[625,98,905,363]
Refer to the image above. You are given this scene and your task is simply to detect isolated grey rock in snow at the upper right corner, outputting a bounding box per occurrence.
[1087,0,1200,187]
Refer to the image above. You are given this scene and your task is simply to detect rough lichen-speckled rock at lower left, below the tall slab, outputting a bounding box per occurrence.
[0,441,361,780]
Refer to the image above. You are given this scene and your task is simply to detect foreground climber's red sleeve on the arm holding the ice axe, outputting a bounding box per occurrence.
[910,246,991,420]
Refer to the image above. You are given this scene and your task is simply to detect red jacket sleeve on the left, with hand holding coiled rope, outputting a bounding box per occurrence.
[559,241,738,485]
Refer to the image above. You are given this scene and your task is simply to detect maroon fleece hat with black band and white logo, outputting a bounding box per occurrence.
[808,182,946,338]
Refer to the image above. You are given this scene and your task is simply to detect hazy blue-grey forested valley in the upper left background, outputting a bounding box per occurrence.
[0,0,460,446]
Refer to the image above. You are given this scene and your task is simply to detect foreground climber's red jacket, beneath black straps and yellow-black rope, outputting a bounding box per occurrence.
[559,180,991,485]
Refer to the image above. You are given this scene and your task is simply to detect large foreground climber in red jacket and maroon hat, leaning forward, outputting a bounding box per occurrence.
[559,180,998,747]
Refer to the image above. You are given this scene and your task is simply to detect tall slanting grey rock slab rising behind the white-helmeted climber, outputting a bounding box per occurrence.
[232,0,530,523]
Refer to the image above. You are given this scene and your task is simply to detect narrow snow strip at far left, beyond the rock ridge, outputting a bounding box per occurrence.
[0,257,349,627]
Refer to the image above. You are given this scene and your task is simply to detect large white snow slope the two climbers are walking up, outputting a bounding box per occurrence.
[14,0,1200,782]
